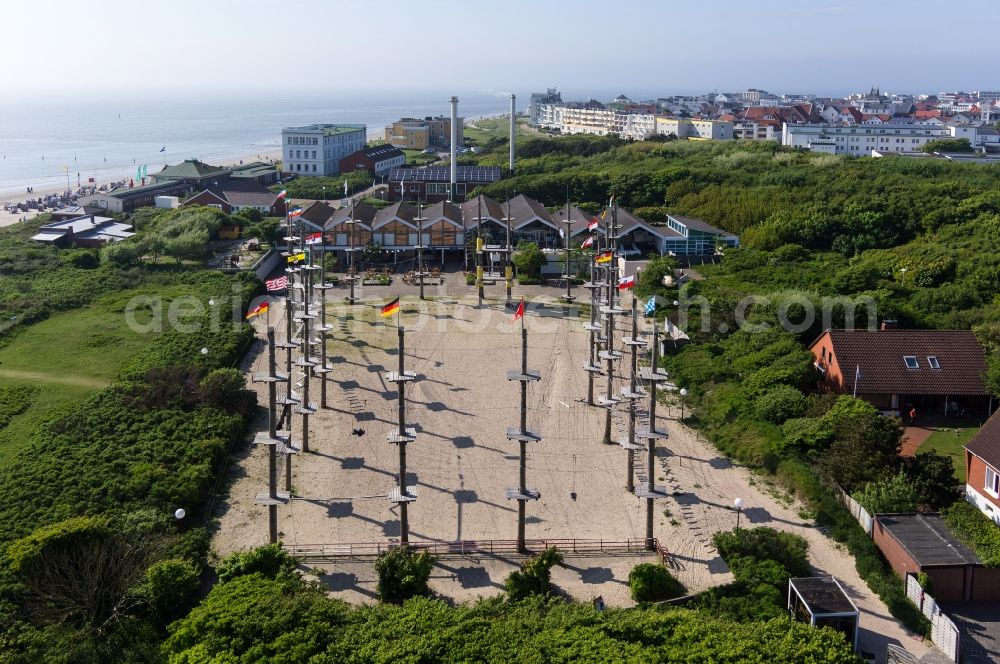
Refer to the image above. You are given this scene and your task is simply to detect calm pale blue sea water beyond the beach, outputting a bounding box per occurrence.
[0,93,512,194]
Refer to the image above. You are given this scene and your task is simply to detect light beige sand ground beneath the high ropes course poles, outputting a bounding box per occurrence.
[213,278,927,661]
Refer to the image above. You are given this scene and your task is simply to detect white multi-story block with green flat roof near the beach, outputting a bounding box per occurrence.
[281,124,368,176]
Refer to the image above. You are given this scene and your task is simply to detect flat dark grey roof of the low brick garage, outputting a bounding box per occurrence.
[875,514,981,567]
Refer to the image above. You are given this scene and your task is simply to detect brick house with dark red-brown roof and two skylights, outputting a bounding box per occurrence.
[810,325,993,418]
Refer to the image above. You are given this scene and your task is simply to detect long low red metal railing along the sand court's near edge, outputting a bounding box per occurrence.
[285,538,670,561]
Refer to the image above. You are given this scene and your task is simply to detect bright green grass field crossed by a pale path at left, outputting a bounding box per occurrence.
[0,286,201,465]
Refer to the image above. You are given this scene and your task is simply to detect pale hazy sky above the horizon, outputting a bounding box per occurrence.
[7,0,1000,100]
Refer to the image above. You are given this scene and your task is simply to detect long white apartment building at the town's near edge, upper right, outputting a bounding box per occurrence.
[781,120,951,157]
